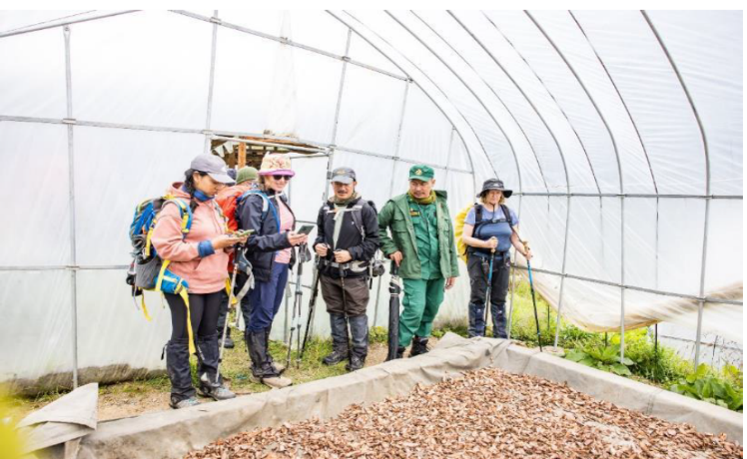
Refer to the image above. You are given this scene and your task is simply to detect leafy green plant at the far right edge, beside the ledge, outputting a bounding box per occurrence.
[670,363,743,411]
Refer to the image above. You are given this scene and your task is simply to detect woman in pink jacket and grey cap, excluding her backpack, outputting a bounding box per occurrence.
[151,155,246,409]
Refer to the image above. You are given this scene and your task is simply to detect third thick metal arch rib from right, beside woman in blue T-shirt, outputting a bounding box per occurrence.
[447,11,571,347]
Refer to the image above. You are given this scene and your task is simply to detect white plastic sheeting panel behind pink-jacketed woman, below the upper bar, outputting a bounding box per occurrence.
[74,127,205,266]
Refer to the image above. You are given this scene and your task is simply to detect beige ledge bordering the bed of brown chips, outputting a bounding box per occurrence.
[50,334,743,459]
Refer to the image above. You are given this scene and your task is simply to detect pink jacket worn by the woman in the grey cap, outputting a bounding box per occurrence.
[151,183,228,293]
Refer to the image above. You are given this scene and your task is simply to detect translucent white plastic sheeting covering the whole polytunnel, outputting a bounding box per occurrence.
[0,11,743,388]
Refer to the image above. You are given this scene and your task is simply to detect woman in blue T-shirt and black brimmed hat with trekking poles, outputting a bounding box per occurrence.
[457,178,532,338]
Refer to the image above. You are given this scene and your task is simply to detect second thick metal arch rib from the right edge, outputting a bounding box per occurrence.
[524,10,625,361]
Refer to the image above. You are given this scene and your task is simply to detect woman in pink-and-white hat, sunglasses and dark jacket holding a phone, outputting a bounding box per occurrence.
[237,154,307,387]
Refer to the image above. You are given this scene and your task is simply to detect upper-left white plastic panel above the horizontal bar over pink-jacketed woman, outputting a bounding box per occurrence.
[71,12,211,129]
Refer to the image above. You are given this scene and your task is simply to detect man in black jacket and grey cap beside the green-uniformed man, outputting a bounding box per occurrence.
[314,167,379,371]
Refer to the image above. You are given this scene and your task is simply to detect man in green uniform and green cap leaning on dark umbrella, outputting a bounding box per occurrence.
[379,165,459,357]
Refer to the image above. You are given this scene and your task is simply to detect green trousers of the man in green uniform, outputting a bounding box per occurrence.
[399,278,446,347]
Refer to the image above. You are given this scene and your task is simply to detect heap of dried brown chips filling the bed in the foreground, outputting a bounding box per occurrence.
[186,368,744,459]
